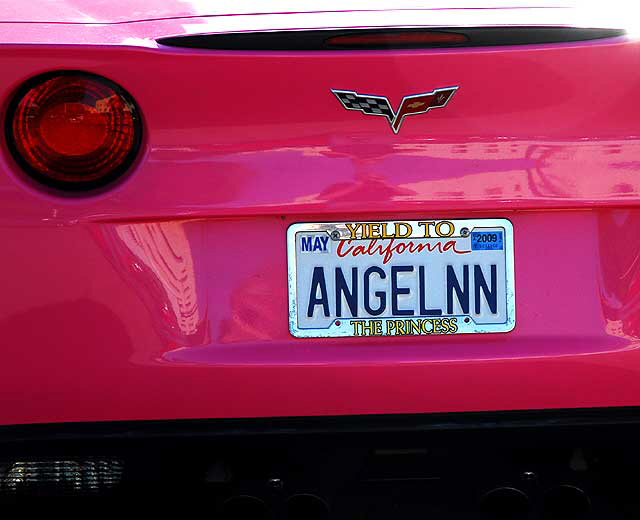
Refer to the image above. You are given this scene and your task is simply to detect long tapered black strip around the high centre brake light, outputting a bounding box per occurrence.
[157,27,626,51]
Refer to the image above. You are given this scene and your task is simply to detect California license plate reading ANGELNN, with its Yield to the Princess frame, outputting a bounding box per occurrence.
[287,219,515,338]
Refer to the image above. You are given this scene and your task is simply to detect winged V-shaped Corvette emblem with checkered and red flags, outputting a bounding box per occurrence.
[331,87,460,134]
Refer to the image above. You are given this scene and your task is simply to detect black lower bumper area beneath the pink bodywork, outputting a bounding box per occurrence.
[0,408,640,520]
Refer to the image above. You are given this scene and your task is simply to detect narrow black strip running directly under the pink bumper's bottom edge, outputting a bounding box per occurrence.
[0,407,640,443]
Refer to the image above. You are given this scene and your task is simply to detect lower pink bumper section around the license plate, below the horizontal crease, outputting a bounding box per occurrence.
[0,209,640,424]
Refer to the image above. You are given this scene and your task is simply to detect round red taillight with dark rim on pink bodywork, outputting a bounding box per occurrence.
[6,72,142,190]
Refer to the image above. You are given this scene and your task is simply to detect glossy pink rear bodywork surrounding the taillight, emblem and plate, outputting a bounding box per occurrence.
[0,11,640,424]
